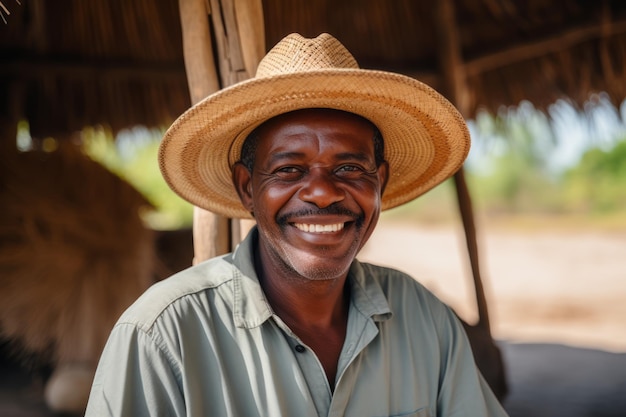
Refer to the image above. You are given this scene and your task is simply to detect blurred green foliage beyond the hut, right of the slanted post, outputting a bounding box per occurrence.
[458,104,626,223]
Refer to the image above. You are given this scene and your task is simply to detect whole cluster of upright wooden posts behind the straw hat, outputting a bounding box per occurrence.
[179,0,265,264]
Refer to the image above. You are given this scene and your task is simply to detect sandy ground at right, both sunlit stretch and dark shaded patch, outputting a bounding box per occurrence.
[360,220,626,417]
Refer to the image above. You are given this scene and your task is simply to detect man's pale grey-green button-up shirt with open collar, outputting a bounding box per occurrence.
[86,230,506,417]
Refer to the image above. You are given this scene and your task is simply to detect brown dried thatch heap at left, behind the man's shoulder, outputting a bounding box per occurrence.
[0,141,155,365]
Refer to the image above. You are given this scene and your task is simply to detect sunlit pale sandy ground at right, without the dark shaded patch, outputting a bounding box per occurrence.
[359,220,626,352]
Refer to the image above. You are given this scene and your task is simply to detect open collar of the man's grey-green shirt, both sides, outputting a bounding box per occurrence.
[225,227,391,328]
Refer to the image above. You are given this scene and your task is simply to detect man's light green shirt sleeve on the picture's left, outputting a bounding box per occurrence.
[85,323,186,417]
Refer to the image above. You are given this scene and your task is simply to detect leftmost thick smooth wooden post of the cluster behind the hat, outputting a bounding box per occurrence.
[179,0,230,264]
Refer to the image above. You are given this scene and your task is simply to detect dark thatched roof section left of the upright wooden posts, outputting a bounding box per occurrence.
[0,0,190,139]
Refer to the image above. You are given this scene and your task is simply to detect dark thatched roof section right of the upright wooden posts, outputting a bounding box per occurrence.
[263,0,626,117]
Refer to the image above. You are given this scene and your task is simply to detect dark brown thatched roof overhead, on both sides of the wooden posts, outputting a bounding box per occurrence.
[0,0,626,140]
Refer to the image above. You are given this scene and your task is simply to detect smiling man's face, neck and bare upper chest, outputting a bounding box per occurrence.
[233,109,389,389]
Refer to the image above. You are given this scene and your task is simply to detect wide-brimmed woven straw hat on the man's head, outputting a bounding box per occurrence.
[159,33,470,218]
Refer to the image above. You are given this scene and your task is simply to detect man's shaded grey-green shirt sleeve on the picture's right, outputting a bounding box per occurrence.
[437,307,507,417]
